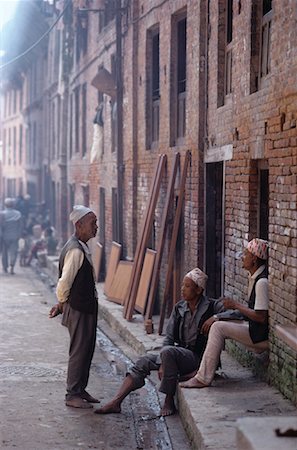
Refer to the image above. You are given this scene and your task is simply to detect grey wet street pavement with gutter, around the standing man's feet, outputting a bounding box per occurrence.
[0,268,189,450]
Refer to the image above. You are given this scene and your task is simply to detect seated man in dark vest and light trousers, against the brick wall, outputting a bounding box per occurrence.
[180,239,269,388]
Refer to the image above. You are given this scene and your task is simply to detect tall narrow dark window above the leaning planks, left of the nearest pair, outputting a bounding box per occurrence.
[146,28,160,148]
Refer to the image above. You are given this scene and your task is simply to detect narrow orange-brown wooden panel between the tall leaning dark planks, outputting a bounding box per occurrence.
[134,248,157,314]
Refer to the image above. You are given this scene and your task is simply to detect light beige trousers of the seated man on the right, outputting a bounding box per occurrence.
[195,321,268,385]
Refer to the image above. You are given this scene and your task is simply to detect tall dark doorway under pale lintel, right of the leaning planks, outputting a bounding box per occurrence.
[205,162,224,298]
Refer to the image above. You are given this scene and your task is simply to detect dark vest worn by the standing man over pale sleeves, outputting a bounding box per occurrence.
[59,236,97,314]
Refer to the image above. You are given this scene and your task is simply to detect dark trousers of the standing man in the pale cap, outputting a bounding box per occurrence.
[62,303,97,400]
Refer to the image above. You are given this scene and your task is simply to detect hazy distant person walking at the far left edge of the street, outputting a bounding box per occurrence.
[1,198,22,274]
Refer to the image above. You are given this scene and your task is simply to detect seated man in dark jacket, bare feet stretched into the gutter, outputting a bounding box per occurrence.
[94,268,223,416]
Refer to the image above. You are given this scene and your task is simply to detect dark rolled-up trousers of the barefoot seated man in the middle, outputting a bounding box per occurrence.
[129,345,199,396]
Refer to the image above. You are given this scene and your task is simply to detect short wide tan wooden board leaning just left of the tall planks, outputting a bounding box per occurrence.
[107,261,133,305]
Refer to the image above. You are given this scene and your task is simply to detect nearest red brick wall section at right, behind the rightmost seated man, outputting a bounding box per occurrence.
[208,0,297,401]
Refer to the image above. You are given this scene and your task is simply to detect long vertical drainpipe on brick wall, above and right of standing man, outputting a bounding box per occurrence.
[116,0,124,244]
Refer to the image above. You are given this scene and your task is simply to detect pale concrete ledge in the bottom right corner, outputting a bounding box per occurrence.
[236,417,297,450]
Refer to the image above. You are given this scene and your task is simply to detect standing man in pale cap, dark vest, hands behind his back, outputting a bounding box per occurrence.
[49,205,99,408]
